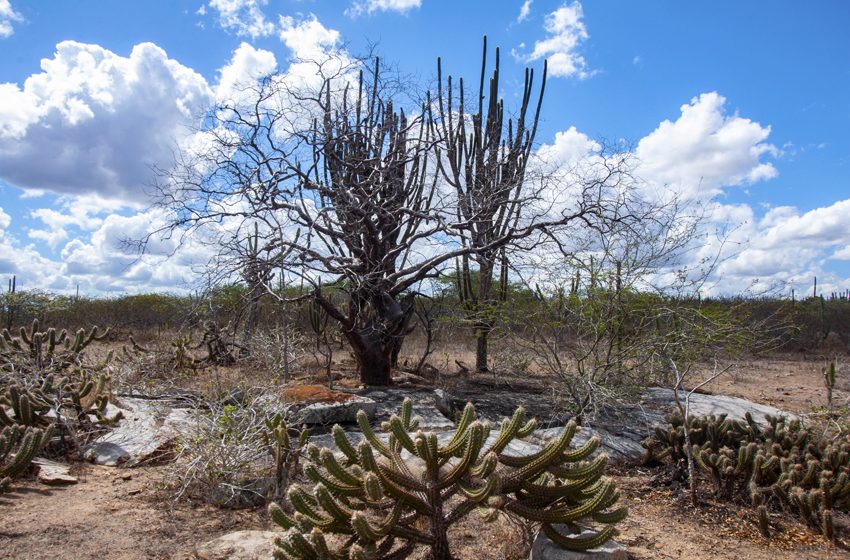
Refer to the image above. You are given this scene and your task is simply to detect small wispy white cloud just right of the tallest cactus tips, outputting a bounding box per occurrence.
[512,2,593,79]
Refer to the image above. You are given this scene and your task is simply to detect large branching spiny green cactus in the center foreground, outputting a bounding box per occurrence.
[270,399,626,560]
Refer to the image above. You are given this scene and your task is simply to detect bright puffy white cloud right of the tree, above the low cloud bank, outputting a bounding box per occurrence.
[635,92,778,198]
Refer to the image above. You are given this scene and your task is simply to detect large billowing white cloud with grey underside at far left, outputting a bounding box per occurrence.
[0,41,212,200]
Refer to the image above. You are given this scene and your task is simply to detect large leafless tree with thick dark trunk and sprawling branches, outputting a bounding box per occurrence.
[151,44,628,385]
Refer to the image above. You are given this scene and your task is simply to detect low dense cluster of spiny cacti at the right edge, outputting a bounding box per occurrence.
[644,414,850,540]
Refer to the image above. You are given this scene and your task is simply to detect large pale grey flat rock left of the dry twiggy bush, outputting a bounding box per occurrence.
[84,398,192,467]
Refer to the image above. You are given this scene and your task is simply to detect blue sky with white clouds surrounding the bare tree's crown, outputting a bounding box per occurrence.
[0,0,850,294]
